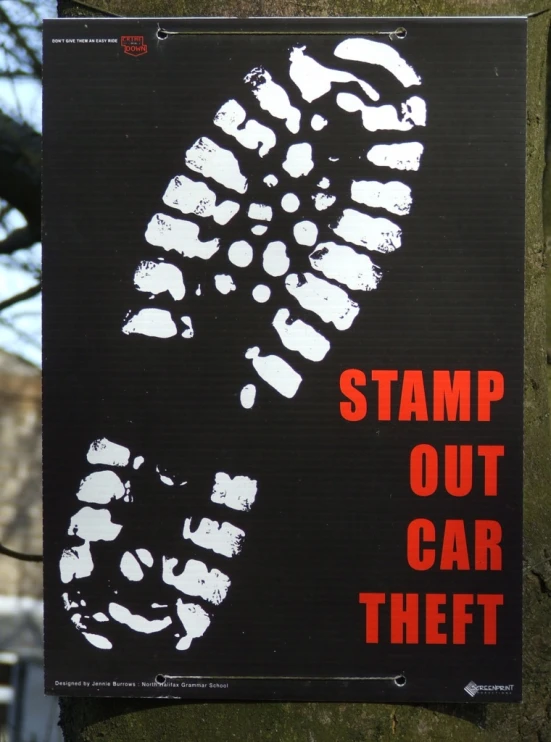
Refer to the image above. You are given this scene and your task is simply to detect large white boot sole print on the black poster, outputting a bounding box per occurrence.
[60,37,426,651]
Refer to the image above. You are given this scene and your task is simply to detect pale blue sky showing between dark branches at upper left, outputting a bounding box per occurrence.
[0,0,56,366]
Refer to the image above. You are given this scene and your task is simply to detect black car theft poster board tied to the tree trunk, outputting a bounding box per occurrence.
[44,18,526,701]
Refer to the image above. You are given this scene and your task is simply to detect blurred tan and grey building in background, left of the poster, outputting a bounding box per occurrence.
[0,349,61,742]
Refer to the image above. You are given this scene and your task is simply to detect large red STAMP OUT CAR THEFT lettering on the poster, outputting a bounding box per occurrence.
[340,368,505,644]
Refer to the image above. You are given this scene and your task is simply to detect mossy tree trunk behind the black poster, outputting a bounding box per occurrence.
[55,0,551,742]
